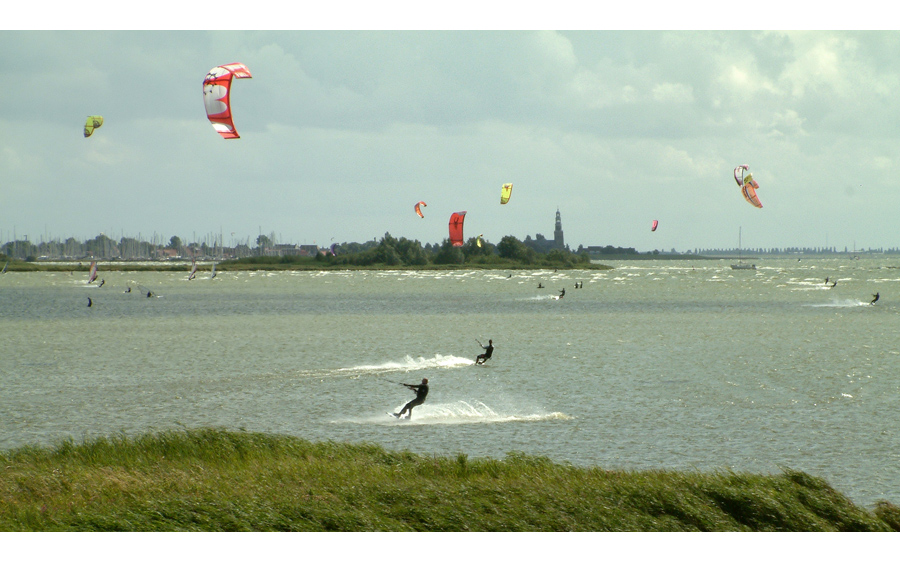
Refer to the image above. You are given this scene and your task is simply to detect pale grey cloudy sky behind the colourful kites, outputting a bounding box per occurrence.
[0,6,900,252]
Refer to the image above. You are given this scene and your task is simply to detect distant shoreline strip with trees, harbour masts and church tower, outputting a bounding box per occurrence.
[0,209,900,265]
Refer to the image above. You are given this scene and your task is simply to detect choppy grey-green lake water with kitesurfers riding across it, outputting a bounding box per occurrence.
[0,258,900,506]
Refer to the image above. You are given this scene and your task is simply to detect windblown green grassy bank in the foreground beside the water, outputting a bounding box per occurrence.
[0,430,900,531]
